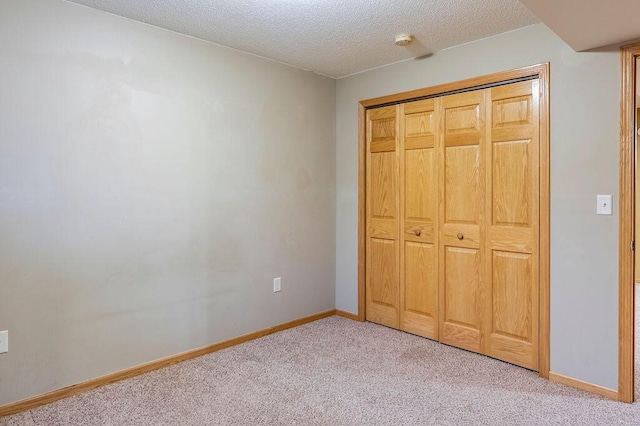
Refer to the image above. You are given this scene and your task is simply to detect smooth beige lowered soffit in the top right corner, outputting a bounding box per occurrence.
[520,0,640,51]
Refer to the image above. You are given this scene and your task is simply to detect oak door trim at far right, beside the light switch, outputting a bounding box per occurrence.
[618,44,640,402]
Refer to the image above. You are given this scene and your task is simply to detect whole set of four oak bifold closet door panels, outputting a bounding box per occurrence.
[364,78,540,370]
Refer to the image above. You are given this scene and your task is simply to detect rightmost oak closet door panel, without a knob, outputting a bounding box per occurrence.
[485,80,540,370]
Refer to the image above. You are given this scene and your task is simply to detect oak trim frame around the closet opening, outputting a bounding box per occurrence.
[358,63,552,378]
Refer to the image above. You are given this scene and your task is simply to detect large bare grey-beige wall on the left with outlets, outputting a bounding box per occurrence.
[0,0,335,405]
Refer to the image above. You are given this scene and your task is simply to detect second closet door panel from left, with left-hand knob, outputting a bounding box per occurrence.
[400,99,438,339]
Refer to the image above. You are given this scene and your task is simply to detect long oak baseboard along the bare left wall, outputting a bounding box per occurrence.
[0,309,336,417]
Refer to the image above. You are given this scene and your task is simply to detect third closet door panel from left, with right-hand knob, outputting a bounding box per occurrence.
[439,90,486,352]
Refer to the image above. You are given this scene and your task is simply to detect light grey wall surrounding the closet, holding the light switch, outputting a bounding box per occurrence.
[336,24,620,389]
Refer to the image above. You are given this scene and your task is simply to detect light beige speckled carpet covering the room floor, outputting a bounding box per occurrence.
[0,316,640,425]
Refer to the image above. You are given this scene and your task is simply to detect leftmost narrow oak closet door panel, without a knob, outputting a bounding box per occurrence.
[366,106,399,328]
